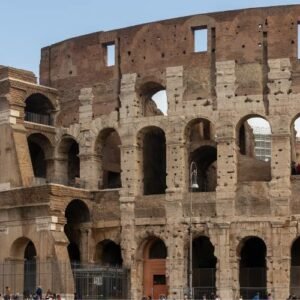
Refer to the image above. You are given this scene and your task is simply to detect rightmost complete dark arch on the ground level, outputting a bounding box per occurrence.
[239,237,267,299]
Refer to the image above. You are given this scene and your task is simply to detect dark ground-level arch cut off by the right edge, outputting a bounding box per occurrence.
[290,238,300,296]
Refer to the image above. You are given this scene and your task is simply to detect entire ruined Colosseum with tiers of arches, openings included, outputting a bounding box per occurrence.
[0,5,300,300]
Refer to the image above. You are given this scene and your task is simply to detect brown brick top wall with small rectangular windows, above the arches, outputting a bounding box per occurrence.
[40,5,300,126]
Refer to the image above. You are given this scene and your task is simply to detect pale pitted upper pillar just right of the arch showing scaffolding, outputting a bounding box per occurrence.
[268,58,293,216]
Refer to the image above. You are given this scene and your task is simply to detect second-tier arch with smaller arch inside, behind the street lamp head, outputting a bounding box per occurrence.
[185,119,217,192]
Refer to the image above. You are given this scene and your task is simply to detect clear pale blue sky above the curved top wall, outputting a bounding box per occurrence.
[0,0,299,75]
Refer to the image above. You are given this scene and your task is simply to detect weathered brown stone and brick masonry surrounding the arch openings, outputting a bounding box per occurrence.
[0,5,300,299]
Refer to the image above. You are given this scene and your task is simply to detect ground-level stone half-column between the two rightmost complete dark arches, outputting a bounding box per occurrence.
[210,223,234,299]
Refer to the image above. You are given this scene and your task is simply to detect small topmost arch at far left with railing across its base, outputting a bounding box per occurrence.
[25,93,54,126]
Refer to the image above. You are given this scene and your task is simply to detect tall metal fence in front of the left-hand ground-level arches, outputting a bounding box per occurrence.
[0,260,130,300]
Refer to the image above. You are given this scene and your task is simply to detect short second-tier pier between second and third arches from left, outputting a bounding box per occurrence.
[79,153,102,190]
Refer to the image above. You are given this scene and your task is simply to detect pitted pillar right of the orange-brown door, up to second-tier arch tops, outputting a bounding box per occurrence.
[165,121,187,300]
